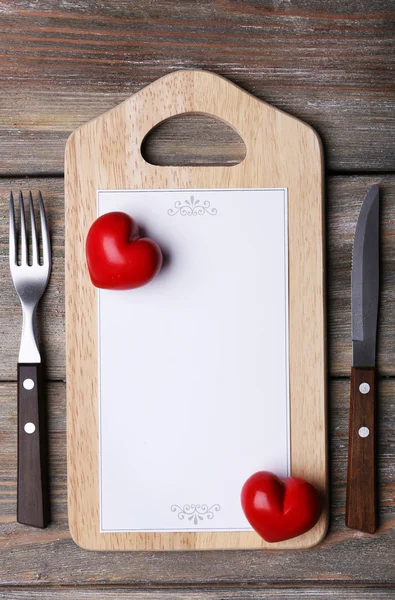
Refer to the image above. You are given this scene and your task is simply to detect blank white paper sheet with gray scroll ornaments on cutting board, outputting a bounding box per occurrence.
[98,189,289,531]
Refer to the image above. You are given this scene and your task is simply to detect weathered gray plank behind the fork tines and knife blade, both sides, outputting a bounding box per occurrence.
[0,176,395,380]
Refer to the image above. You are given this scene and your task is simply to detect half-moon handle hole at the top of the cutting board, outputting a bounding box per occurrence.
[141,113,247,167]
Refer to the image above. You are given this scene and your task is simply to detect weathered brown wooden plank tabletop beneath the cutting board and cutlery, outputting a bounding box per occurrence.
[0,0,395,600]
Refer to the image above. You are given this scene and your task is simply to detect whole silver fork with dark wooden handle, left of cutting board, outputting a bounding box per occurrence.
[9,192,51,527]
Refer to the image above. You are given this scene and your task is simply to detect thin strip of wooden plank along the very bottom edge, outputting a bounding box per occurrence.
[0,585,394,600]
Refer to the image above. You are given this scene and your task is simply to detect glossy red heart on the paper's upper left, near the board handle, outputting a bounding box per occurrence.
[86,212,162,290]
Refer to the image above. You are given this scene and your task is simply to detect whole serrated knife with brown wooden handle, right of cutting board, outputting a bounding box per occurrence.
[346,185,379,533]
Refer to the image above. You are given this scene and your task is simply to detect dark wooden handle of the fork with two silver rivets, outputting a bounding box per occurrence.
[17,364,49,527]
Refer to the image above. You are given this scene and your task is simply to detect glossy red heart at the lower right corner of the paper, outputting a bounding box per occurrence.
[241,471,321,542]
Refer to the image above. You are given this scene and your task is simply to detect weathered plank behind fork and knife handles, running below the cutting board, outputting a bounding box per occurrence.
[0,379,395,580]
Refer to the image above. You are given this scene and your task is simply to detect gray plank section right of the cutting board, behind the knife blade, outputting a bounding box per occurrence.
[327,176,395,375]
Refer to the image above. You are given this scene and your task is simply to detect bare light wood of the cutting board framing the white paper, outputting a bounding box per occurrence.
[65,70,328,550]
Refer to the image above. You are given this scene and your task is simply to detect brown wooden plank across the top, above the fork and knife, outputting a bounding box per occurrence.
[0,0,395,174]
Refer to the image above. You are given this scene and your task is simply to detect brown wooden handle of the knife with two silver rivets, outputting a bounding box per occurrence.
[346,367,376,533]
